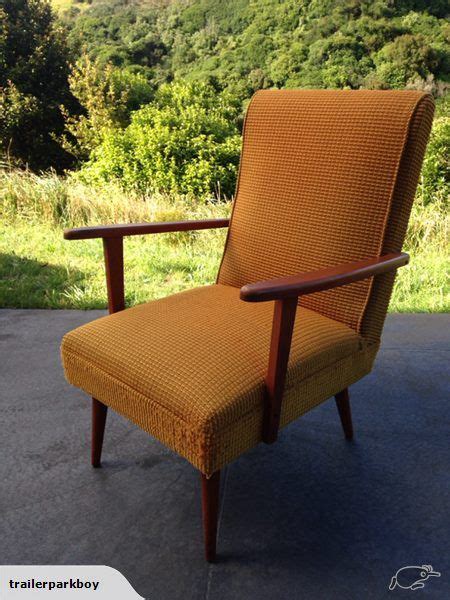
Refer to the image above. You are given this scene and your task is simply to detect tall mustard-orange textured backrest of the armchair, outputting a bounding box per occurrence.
[218,90,434,341]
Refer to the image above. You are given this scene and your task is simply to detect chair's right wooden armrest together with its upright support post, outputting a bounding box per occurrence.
[240,253,409,444]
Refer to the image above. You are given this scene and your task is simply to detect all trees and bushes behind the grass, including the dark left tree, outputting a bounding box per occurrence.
[0,0,450,198]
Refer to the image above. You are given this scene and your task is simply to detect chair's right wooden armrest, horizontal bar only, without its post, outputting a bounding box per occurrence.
[241,252,409,302]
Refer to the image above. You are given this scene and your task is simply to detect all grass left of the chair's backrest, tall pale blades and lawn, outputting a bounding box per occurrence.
[0,172,230,309]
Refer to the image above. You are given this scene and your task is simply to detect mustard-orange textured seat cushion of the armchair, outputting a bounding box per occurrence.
[61,285,376,474]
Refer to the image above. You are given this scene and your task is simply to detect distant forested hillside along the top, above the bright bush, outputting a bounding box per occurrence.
[61,0,450,96]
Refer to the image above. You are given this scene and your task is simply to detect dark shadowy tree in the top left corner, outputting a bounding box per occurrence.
[0,0,76,169]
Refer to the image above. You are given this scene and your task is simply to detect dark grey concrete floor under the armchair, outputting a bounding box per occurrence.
[0,310,450,600]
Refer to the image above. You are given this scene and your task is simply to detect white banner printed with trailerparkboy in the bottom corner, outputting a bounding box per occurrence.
[0,565,144,600]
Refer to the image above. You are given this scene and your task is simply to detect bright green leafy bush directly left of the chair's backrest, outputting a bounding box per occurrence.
[80,83,244,198]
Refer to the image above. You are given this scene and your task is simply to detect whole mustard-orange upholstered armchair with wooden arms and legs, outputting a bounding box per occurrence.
[62,90,433,560]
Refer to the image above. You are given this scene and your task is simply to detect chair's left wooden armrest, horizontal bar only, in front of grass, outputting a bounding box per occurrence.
[64,219,230,240]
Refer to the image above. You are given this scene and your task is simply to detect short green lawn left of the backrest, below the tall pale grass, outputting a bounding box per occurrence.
[0,223,229,309]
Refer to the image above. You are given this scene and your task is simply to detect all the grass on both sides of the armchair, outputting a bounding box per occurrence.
[0,171,450,312]
